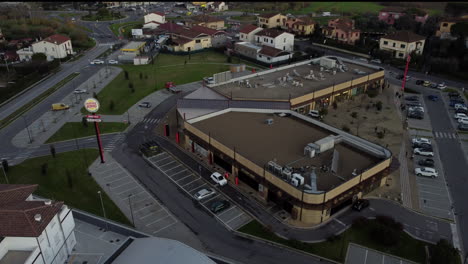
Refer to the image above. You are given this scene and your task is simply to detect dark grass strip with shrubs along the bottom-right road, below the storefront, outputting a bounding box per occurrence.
[238,220,429,263]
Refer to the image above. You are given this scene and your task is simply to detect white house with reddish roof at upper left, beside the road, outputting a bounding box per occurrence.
[32,34,74,61]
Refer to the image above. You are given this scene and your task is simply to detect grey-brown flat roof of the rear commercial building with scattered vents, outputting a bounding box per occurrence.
[210,56,379,100]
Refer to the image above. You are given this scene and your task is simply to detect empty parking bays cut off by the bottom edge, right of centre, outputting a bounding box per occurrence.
[345,243,416,264]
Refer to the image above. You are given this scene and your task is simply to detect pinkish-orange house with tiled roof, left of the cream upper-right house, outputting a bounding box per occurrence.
[322,18,361,45]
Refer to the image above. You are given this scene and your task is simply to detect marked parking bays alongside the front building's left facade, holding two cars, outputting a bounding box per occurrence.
[149,152,252,230]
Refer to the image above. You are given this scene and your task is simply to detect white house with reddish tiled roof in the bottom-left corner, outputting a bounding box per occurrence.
[0,184,76,264]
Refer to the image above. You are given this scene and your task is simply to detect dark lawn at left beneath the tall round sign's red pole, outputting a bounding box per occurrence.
[0,149,131,226]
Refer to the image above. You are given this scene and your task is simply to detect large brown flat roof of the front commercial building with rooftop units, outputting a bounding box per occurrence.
[189,110,383,191]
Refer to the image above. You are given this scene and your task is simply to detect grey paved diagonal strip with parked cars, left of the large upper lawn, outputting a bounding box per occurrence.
[12,67,122,148]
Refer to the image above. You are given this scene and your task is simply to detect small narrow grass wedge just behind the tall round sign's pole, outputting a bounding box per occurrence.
[46,122,128,143]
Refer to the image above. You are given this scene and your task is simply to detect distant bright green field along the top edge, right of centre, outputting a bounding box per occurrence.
[284,2,384,14]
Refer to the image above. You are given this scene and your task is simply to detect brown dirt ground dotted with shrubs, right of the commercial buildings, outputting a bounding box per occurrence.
[323,85,403,201]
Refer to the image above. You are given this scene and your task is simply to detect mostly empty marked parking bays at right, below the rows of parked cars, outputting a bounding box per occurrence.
[412,137,453,219]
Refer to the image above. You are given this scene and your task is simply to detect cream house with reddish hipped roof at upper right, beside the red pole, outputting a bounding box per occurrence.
[379,31,426,59]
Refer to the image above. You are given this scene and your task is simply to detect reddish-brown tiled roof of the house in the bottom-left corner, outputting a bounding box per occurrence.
[0,184,63,237]
